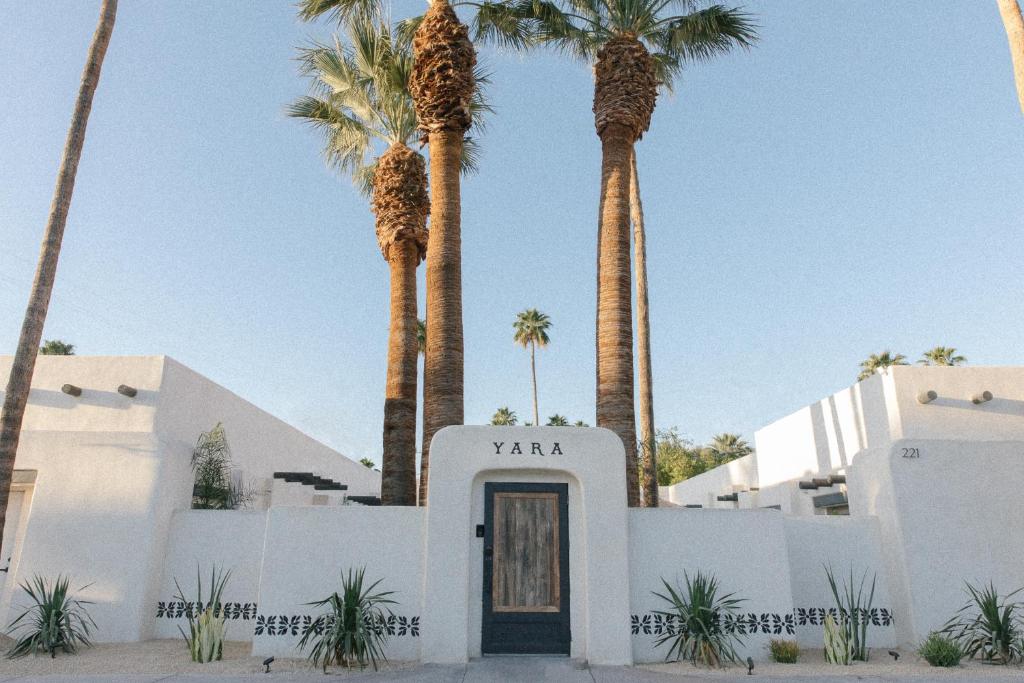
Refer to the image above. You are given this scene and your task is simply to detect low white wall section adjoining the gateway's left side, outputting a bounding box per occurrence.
[253,506,424,661]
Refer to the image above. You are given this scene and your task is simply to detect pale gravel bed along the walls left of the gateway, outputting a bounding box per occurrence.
[0,639,415,676]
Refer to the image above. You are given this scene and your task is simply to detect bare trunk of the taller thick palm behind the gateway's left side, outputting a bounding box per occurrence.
[420,130,464,505]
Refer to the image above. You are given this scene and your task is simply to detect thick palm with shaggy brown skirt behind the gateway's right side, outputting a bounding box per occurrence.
[519,0,756,507]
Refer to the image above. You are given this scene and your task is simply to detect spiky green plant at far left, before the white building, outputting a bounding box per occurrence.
[7,574,96,659]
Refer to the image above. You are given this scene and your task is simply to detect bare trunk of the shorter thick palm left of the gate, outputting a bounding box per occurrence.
[381,240,420,505]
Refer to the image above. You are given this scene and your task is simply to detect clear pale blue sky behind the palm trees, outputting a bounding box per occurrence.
[0,0,1024,462]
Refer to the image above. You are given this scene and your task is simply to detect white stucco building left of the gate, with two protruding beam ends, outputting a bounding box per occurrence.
[0,356,380,642]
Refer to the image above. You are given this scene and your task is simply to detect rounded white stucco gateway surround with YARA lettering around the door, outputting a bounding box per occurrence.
[422,427,632,665]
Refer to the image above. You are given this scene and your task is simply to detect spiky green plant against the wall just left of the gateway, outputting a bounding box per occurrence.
[298,567,395,673]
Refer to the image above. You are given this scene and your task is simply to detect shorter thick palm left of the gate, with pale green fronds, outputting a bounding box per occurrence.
[289,16,430,505]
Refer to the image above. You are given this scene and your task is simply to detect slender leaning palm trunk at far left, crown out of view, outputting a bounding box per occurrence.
[0,0,118,537]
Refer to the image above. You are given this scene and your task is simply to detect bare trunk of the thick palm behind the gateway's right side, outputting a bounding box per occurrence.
[597,124,640,507]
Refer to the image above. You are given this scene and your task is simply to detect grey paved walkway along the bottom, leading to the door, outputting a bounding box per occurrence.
[0,657,1024,683]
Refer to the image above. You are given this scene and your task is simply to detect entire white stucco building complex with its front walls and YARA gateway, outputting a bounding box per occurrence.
[0,357,1024,664]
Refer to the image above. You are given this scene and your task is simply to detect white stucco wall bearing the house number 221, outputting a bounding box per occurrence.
[849,439,1024,643]
